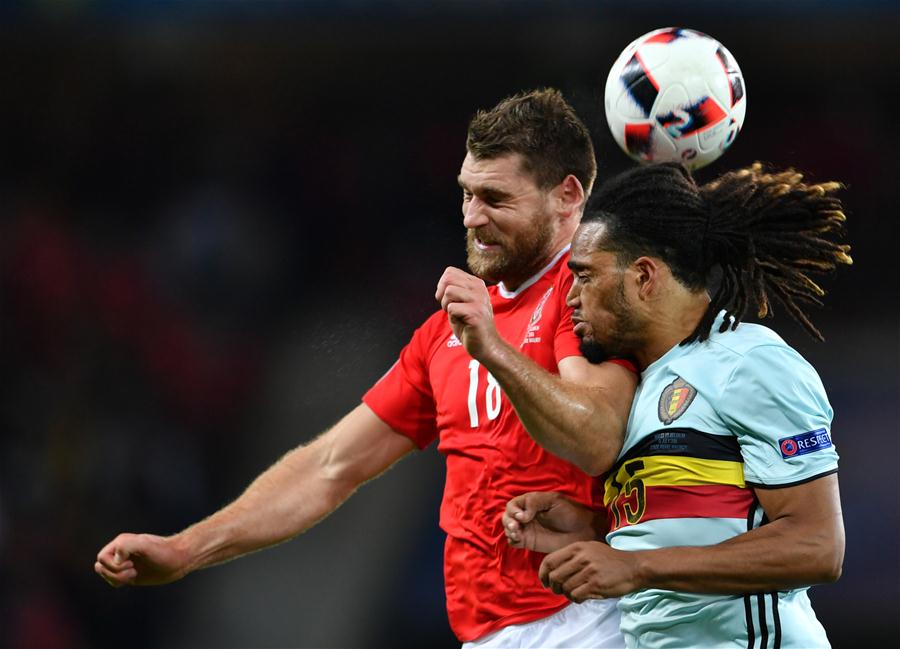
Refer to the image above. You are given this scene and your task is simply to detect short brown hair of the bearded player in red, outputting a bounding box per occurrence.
[466,88,597,194]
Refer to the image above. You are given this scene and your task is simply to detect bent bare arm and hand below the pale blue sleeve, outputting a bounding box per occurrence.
[540,475,844,601]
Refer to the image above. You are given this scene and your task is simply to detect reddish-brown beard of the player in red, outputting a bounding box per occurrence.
[466,212,553,284]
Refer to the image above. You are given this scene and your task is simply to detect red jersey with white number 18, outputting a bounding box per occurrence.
[363,250,602,642]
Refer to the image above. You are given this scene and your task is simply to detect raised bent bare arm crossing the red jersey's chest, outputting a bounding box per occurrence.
[437,268,637,475]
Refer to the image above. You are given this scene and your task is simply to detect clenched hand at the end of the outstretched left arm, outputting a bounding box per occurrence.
[94,534,187,588]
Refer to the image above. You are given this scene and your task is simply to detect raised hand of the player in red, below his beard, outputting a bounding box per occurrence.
[435,266,500,358]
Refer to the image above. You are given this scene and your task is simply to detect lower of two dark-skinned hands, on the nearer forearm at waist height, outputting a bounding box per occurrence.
[538,541,644,604]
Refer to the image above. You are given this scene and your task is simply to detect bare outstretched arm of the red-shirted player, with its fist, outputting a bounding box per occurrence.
[94,404,415,586]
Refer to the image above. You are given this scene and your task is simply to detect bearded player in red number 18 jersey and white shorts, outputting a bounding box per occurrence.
[95,90,636,647]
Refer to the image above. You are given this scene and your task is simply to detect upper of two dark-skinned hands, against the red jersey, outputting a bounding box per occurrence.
[503,491,597,552]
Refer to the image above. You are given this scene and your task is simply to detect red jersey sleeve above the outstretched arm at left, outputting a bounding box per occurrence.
[363,327,438,448]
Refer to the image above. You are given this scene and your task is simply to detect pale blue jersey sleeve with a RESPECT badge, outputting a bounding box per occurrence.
[721,345,838,487]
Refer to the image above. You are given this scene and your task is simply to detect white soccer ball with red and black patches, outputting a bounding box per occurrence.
[605,27,747,169]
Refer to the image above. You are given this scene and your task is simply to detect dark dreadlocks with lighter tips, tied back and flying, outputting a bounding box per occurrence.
[584,162,853,344]
